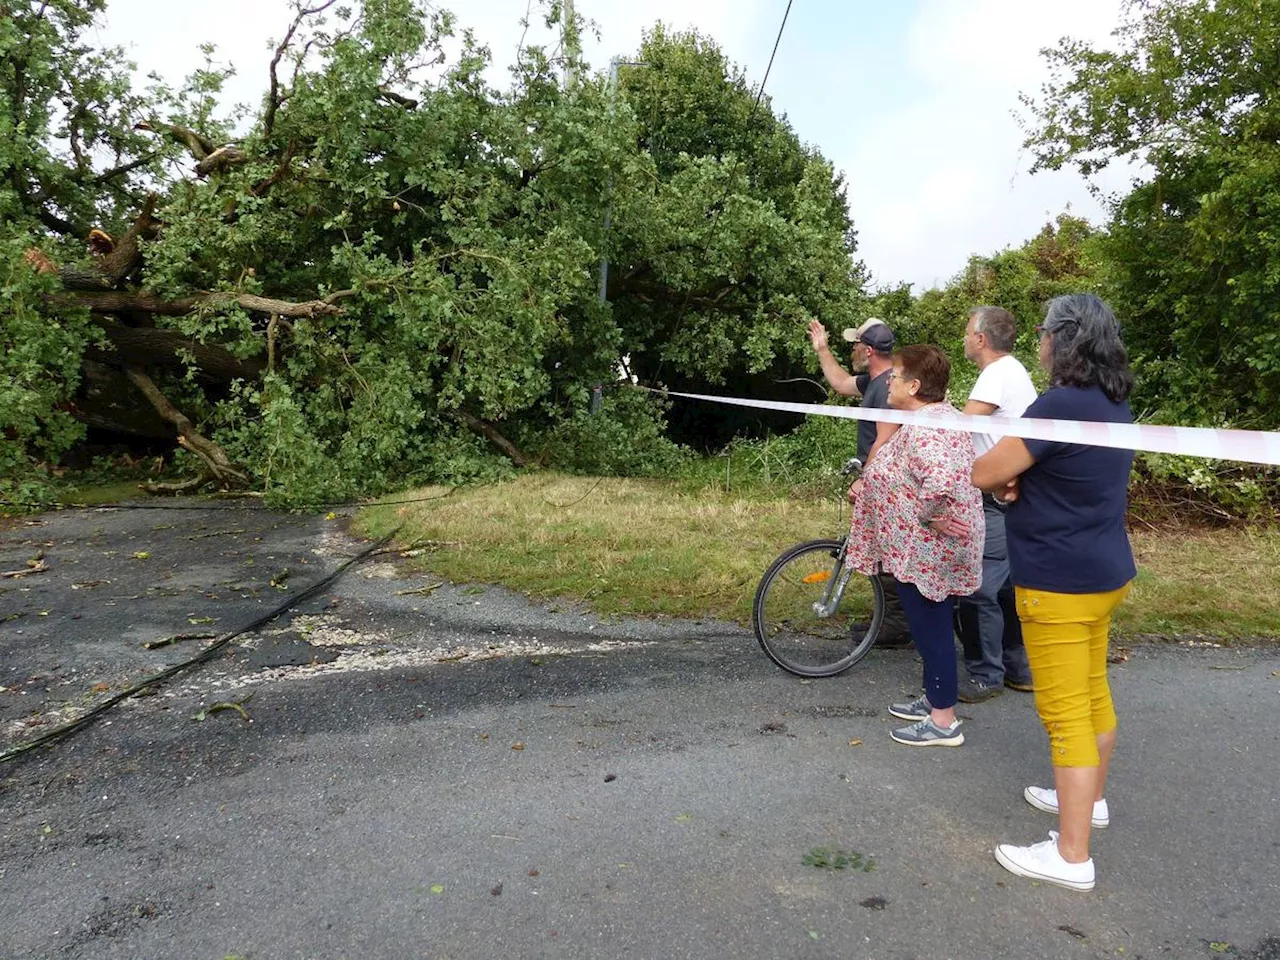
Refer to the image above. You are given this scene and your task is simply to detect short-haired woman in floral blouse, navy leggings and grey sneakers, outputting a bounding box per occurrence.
[846,346,984,746]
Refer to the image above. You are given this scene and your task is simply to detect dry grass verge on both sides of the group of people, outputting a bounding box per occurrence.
[357,472,1280,640]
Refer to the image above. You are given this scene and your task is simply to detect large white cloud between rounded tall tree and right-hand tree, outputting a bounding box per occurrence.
[835,0,1124,289]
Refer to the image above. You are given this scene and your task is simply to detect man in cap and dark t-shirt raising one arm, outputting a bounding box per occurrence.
[809,316,911,646]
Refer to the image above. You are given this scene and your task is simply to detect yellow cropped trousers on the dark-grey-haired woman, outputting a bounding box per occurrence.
[1015,584,1129,767]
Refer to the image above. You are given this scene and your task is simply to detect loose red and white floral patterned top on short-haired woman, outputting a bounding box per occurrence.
[845,403,986,600]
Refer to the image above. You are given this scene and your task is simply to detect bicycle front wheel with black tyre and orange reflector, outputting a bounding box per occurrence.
[751,540,884,677]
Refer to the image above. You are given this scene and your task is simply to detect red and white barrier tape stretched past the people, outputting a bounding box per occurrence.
[640,387,1280,465]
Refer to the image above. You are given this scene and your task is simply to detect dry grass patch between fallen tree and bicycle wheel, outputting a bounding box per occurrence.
[360,474,844,621]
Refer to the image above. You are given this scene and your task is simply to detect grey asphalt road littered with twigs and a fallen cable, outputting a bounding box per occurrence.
[0,508,1280,960]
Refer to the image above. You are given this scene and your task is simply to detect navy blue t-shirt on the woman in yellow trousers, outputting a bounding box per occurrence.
[1005,387,1138,594]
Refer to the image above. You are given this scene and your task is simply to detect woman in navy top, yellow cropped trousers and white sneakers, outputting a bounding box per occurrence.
[973,293,1137,890]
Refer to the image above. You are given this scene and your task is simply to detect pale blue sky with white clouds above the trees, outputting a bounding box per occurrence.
[91,0,1129,293]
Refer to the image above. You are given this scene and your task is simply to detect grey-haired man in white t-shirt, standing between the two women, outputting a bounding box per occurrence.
[956,306,1036,703]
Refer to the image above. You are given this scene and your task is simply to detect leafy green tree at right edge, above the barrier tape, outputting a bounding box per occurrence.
[1025,0,1280,429]
